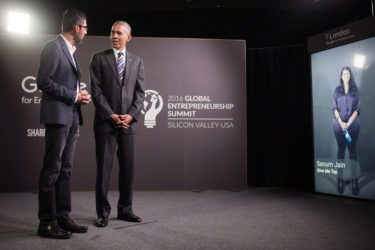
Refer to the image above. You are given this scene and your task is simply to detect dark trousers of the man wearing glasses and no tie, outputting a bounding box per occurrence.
[38,112,79,225]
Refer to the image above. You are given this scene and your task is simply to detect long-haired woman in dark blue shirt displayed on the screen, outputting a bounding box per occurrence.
[332,66,360,195]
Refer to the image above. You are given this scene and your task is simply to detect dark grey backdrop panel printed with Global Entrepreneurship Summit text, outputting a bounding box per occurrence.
[0,34,246,192]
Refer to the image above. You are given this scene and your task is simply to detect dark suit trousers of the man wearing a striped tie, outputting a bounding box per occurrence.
[95,131,135,217]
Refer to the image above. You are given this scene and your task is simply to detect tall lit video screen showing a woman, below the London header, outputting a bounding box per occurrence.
[311,37,375,200]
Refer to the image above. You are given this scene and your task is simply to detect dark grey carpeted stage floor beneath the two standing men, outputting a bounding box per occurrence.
[0,188,375,250]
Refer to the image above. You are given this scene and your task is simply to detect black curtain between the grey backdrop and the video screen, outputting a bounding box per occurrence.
[247,45,314,190]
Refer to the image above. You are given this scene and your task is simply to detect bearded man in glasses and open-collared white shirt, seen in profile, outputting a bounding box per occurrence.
[37,9,91,239]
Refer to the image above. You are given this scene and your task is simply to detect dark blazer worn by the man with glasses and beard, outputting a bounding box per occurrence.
[37,36,82,125]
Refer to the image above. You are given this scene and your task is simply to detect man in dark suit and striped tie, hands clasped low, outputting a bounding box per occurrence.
[90,21,145,227]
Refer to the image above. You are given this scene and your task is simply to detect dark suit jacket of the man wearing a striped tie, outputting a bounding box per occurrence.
[90,49,145,134]
